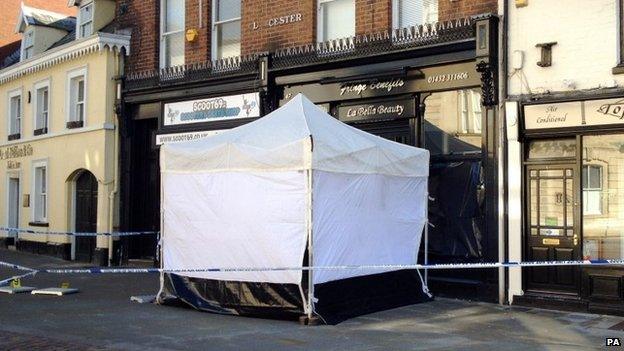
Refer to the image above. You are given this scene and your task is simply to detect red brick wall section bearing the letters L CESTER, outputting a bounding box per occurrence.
[241,0,316,55]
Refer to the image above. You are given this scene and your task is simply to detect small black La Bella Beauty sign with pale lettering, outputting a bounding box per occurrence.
[338,99,416,122]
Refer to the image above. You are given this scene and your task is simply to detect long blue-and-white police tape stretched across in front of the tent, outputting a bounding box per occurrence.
[0,259,624,274]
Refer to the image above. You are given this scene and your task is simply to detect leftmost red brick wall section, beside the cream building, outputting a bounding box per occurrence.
[117,0,160,72]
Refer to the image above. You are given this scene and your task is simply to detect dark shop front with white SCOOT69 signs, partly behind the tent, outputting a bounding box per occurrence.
[120,57,266,263]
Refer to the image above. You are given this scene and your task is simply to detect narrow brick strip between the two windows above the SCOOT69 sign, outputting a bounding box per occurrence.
[184,0,212,64]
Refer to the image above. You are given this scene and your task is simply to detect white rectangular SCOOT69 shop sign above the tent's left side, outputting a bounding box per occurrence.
[163,93,260,126]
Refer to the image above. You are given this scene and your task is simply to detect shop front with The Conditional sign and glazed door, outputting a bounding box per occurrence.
[513,96,624,314]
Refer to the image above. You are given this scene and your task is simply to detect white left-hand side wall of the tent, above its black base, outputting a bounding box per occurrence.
[162,171,307,284]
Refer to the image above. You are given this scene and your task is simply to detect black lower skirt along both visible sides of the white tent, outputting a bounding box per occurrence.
[159,270,432,325]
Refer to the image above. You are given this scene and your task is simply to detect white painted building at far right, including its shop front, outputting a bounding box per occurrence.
[501,0,624,313]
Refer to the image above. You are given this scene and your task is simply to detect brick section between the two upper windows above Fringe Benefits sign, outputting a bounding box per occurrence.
[355,0,392,35]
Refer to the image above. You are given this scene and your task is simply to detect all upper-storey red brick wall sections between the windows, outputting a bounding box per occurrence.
[117,0,497,71]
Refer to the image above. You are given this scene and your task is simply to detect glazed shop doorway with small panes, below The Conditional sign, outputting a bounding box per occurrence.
[524,144,582,297]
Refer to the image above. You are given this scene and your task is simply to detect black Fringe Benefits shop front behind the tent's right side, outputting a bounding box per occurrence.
[271,16,498,301]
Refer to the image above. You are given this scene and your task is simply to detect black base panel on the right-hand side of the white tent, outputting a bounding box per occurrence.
[314,270,433,324]
